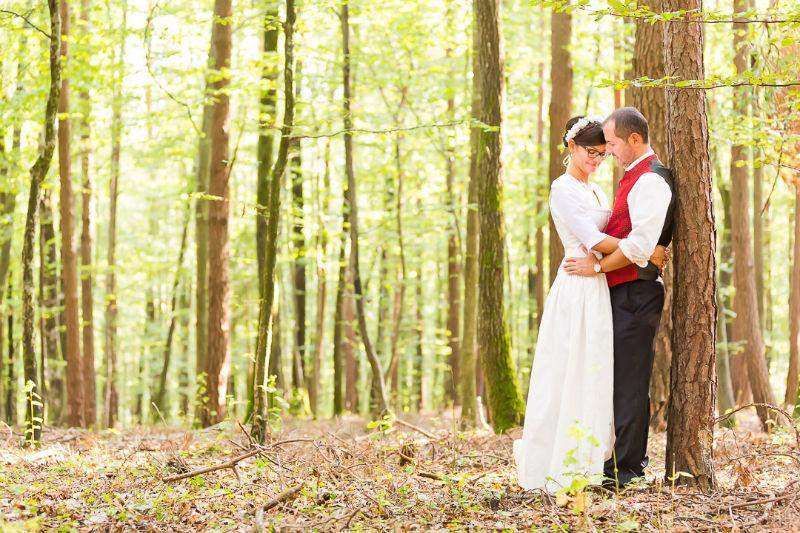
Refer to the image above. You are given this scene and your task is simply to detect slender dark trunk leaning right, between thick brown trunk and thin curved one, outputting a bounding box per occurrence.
[253,0,295,442]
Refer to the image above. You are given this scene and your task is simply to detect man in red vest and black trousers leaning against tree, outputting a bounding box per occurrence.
[565,107,675,488]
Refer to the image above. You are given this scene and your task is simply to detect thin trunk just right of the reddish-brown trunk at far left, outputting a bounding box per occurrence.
[80,0,97,426]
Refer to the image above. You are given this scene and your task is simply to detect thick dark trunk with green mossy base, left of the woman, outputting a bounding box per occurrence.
[475,0,525,433]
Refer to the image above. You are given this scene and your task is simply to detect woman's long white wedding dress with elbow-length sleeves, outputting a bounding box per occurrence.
[514,170,614,492]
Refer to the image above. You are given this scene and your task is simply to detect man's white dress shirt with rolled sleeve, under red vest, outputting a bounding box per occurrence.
[619,149,672,267]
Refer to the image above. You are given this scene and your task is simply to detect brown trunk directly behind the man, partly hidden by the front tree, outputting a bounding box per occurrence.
[625,0,672,430]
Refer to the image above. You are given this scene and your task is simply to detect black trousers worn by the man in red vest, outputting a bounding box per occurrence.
[605,280,664,486]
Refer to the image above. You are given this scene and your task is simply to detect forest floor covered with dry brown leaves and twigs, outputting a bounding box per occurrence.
[0,413,800,531]
